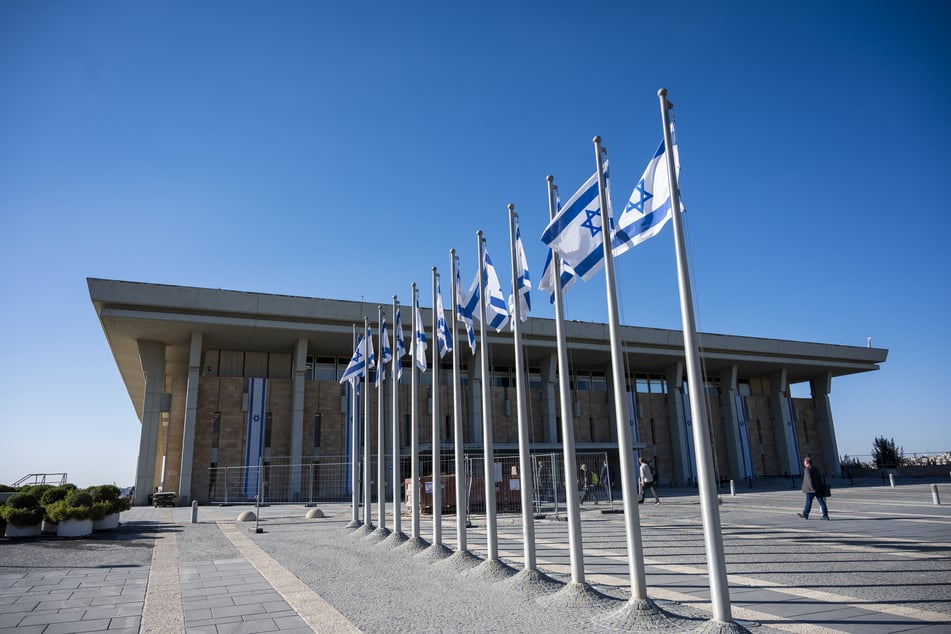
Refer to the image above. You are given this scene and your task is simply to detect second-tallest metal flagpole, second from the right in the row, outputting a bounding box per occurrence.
[594,136,647,601]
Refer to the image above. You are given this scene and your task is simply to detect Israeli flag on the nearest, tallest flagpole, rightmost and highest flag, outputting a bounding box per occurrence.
[611,130,680,256]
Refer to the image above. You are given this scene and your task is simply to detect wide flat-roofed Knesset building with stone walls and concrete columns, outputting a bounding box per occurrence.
[87,278,887,505]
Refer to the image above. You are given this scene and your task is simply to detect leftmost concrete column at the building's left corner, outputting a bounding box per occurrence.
[133,341,165,506]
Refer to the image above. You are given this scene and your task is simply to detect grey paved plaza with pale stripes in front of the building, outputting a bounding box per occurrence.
[0,482,951,634]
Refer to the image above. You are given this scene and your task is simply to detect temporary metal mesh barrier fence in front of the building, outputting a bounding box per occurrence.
[208,452,614,513]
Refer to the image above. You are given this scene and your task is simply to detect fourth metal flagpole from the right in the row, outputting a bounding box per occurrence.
[509,204,536,571]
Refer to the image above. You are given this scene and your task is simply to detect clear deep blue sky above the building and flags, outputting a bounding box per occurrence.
[0,0,951,485]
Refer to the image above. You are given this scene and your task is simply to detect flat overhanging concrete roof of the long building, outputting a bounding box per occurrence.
[87,278,888,415]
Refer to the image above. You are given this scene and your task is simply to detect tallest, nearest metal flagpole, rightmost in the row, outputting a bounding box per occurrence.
[657,88,733,623]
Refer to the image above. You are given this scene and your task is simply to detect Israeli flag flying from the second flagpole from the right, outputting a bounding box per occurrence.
[542,161,611,281]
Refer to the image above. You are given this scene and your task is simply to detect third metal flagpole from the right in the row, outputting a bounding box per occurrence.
[547,176,585,584]
